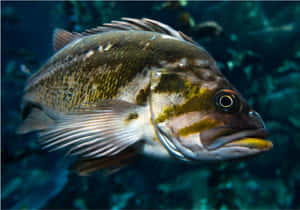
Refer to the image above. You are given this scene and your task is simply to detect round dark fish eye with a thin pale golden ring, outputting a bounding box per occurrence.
[215,90,237,112]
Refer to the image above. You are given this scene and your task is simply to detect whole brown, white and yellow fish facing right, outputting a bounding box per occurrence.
[17,18,273,175]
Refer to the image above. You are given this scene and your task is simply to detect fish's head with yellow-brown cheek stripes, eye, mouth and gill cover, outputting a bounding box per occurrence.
[150,60,272,160]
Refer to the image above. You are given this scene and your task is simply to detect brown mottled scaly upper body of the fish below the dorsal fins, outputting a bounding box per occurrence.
[24,31,215,112]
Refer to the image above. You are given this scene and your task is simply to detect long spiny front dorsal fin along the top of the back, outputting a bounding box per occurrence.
[81,17,198,45]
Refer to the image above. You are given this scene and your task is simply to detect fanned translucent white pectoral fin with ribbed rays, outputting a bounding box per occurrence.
[40,101,143,158]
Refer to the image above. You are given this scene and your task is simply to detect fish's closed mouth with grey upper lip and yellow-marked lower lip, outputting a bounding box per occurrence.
[205,128,273,151]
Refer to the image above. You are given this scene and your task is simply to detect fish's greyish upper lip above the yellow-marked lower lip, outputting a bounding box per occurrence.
[206,127,269,150]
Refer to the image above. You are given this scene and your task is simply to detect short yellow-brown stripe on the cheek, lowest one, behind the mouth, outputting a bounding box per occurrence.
[178,119,218,136]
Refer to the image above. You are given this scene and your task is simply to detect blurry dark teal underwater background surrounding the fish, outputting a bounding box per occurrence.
[1,1,300,210]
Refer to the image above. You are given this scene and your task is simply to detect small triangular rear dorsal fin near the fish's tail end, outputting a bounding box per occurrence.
[53,28,82,52]
